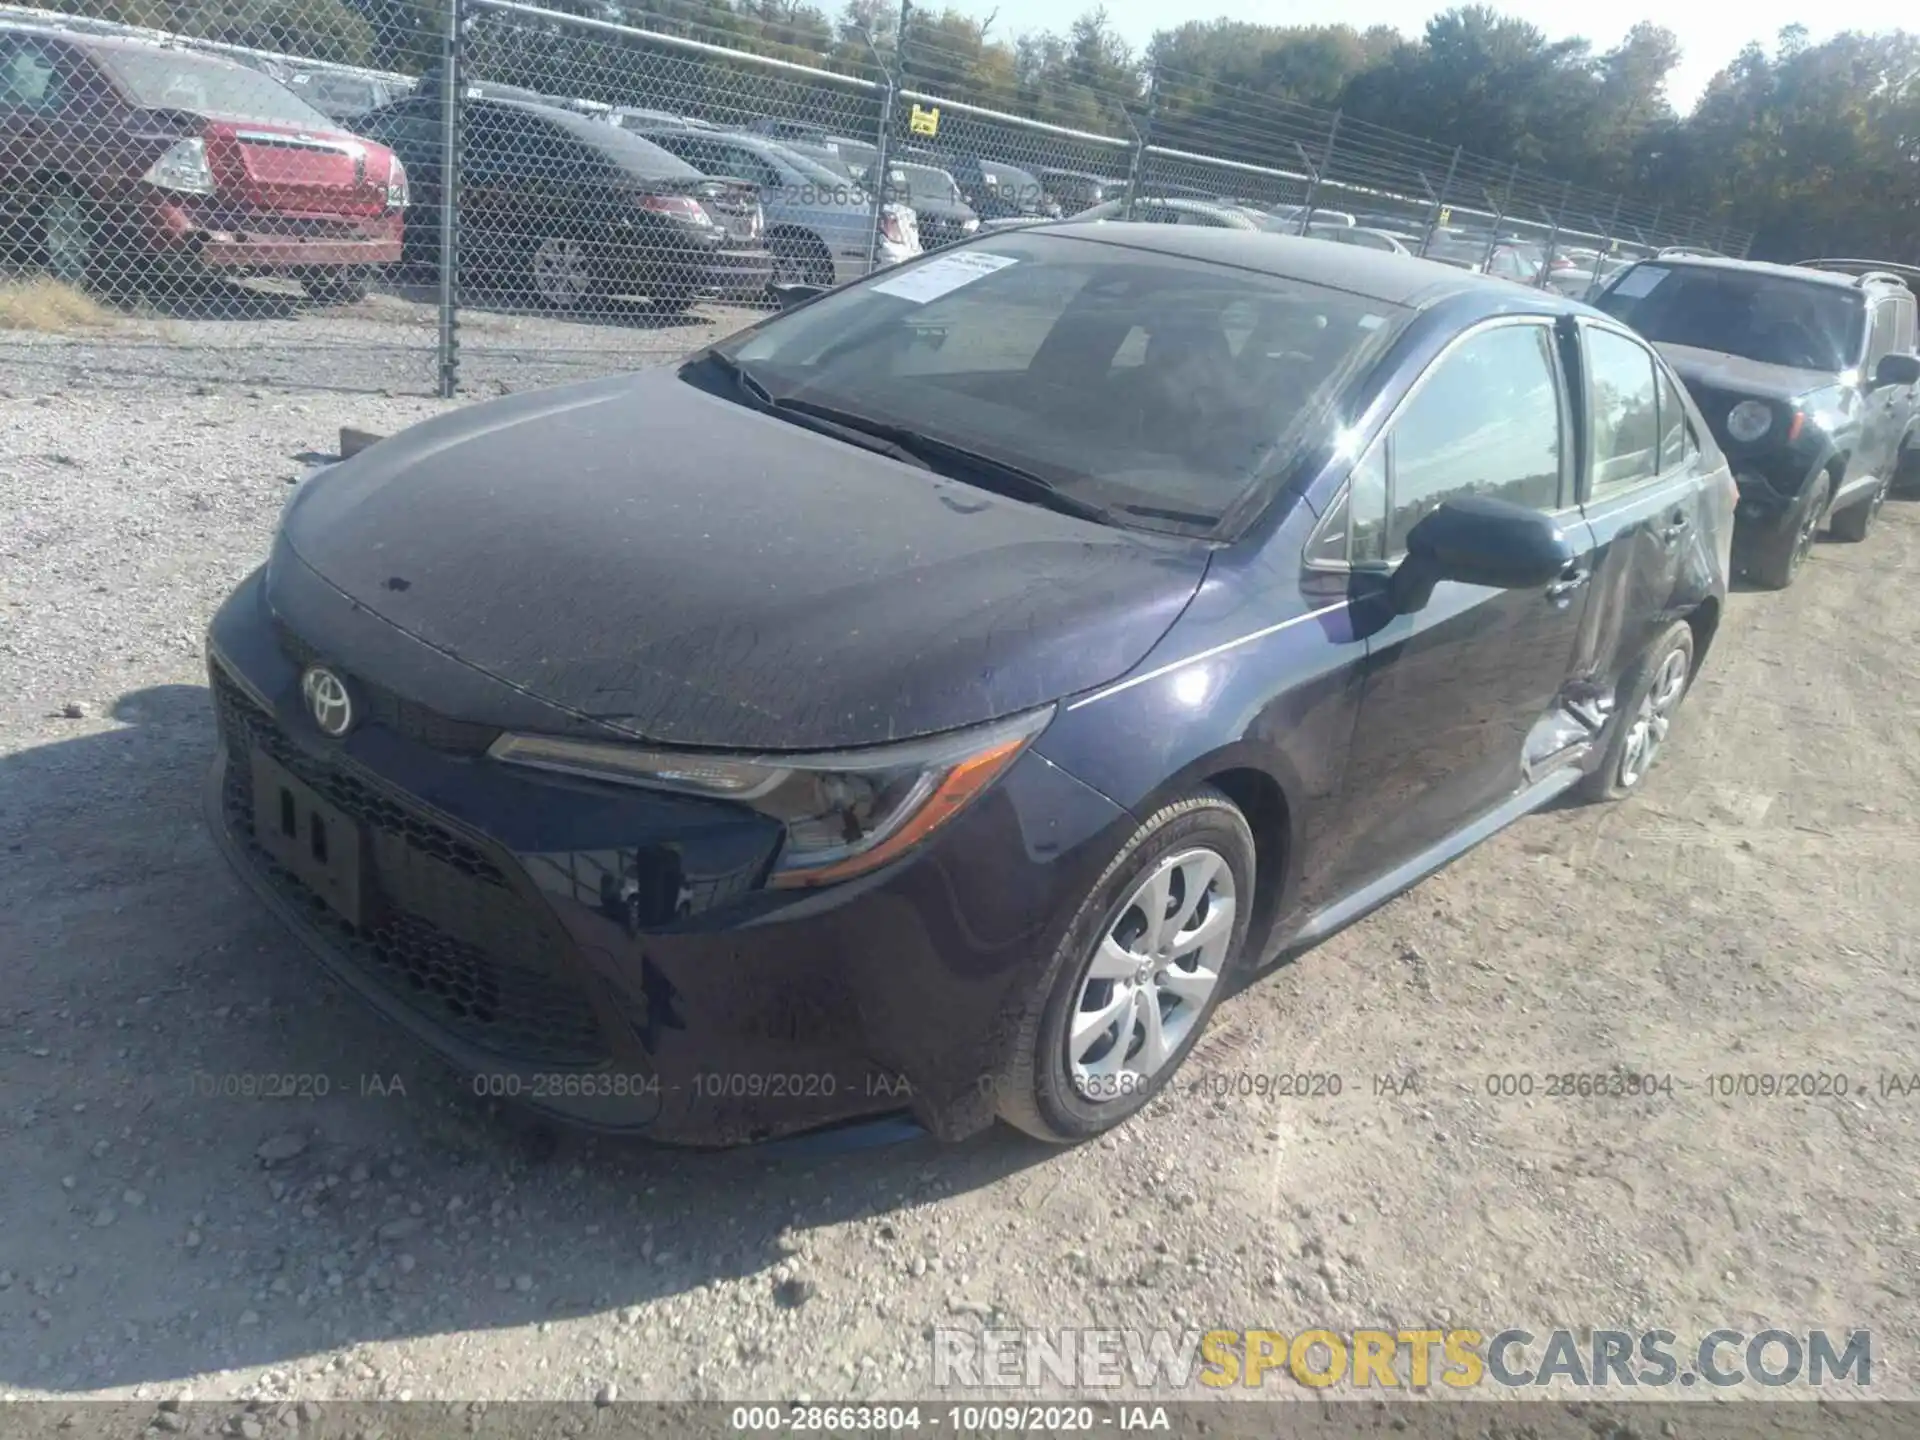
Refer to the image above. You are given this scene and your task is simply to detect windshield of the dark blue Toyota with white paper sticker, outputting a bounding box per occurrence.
[722,230,1404,534]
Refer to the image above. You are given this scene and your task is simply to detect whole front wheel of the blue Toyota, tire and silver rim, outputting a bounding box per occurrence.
[998,787,1256,1144]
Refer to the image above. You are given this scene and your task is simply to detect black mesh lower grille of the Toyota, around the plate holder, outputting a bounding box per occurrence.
[211,664,607,1066]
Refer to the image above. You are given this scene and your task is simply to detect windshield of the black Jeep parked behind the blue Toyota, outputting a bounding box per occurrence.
[1594,265,1866,371]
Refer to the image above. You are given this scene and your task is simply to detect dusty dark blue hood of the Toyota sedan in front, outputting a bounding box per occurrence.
[282,369,1210,751]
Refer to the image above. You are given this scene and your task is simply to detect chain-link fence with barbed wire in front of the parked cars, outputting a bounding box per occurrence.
[0,0,1747,394]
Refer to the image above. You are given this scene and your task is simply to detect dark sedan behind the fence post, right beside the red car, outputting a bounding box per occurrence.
[361,96,774,309]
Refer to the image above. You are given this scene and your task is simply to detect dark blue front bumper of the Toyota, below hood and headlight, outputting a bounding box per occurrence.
[207,576,1133,1144]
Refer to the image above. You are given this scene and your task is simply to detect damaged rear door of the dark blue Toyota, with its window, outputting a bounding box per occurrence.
[1563,319,1715,722]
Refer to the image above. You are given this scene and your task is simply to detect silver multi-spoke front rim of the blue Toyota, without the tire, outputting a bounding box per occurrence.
[1064,849,1235,1102]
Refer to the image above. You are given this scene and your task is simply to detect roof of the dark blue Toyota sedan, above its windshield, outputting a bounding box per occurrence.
[1044,221,1566,315]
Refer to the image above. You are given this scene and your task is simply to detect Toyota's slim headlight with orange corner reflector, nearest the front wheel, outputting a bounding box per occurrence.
[488,707,1054,889]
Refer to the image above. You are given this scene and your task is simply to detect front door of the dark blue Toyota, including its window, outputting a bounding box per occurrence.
[1325,317,1590,895]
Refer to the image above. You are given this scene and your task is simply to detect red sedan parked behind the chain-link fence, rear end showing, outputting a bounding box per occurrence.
[0,29,407,301]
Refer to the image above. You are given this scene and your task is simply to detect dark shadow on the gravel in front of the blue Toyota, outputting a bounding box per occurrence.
[0,685,1056,1392]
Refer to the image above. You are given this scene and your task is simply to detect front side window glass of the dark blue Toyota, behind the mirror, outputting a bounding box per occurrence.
[1386,324,1566,557]
